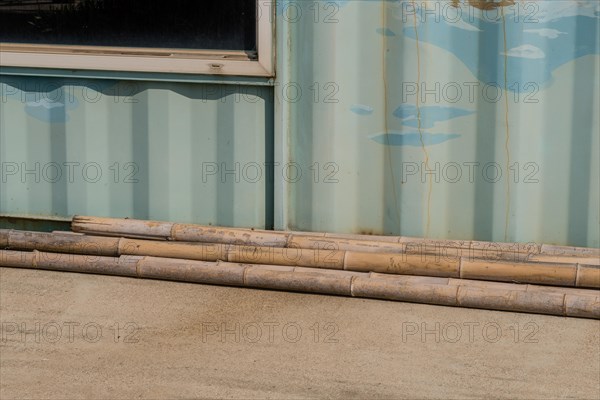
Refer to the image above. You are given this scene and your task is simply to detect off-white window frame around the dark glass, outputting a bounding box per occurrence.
[0,0,276,77]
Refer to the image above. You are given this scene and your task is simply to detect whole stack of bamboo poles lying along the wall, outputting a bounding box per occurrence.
[0,217,600,319]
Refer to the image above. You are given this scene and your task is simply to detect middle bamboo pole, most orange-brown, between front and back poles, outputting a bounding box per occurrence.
[0,231,600,288]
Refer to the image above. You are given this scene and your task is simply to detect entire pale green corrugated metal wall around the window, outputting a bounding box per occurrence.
[0,0,600,247]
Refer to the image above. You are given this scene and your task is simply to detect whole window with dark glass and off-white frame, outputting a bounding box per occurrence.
[0,0,274,76]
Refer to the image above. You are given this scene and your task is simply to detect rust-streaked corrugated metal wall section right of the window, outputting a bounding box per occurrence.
[275,0,600,247]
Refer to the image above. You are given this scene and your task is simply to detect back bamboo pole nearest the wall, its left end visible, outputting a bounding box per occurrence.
[72,216,600,264]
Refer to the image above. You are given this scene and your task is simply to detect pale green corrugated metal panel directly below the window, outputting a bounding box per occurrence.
[0,75,273,227]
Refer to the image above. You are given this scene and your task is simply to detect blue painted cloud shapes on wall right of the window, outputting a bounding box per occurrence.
[351,0,600,146]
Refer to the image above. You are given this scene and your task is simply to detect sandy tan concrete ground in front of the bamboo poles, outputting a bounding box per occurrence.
[0,268,600,400]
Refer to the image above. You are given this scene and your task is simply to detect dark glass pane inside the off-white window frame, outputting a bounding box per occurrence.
[0,0,256,50]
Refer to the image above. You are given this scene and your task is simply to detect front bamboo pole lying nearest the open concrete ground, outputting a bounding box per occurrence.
[0,250,600,319]
